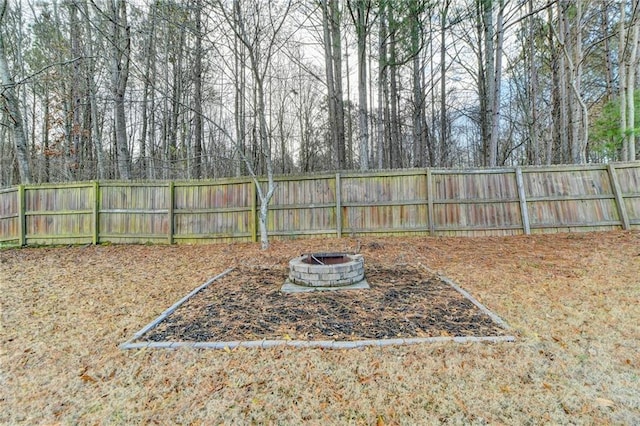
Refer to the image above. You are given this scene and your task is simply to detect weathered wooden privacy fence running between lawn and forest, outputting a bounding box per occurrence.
[0,162,640,245]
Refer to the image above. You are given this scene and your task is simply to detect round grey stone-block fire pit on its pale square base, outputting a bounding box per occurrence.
[282,253,369,293]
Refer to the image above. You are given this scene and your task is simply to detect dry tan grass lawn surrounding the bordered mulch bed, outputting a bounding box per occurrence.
[0,232,640,424]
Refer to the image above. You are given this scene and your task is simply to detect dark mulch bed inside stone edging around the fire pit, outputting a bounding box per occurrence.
[137,265,508,342]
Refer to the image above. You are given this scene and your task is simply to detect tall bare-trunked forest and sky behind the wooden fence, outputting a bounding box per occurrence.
[0,0,640,187]
